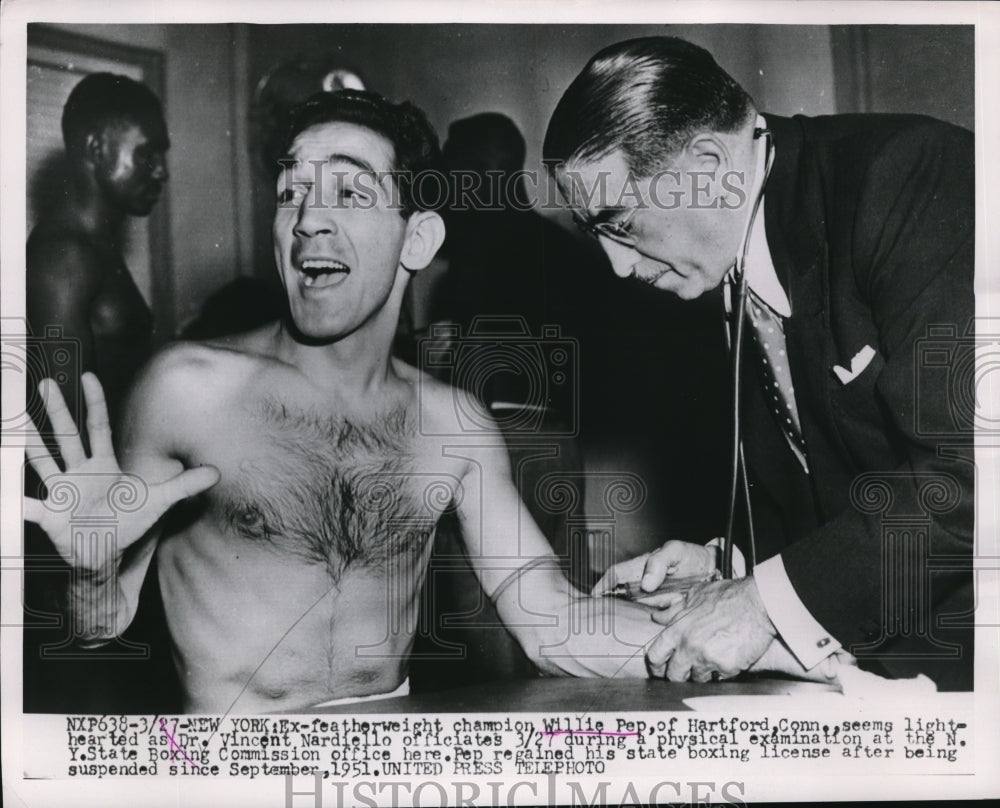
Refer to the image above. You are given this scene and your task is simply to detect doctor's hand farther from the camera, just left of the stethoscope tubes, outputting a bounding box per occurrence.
[591,541,717,607]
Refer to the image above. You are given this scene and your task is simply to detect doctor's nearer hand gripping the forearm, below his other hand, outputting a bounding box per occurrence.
[646,578,776,682]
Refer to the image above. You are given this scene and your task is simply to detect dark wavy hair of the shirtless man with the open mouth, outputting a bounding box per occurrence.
[283,90,441,218]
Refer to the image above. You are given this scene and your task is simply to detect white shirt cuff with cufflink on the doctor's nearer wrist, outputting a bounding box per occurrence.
[753,555,841,670]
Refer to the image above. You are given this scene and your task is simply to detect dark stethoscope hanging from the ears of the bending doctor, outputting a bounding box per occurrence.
[722,127,774,578]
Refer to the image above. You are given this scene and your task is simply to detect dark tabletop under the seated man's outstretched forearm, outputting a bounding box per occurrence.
[310,678,837,714]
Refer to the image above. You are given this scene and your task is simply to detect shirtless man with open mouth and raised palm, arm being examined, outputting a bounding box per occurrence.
[25,93,696,712]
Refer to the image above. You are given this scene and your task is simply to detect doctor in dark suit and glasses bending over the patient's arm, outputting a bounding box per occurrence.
[544,37,975,688]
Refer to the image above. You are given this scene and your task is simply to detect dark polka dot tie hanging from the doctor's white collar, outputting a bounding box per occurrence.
[747,290,809,473]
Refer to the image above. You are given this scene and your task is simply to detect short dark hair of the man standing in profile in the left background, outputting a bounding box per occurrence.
[62,73,163,155]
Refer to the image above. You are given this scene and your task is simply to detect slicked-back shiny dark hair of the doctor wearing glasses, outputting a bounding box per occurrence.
[543,37,753,177]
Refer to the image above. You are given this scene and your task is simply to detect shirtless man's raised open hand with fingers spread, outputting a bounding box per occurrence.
[24,373,219,571]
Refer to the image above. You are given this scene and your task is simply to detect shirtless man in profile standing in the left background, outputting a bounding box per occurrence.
[26,73,170,420]
